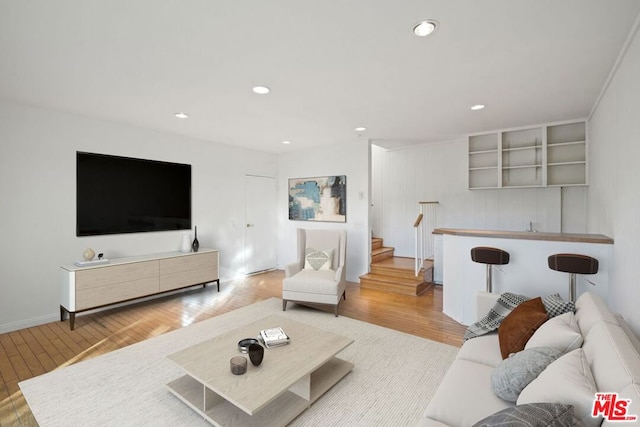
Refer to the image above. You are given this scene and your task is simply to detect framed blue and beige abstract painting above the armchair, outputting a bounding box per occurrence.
[289,175,347,222]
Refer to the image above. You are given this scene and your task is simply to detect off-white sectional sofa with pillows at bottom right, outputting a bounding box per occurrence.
[419,292,640,427]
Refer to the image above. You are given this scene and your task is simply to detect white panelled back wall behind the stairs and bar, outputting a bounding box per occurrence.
[372,140,586,256]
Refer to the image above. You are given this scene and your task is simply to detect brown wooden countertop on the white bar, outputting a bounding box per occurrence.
[433,228,613,244]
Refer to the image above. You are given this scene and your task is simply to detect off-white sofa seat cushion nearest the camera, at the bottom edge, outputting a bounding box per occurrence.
[424,360,513,426]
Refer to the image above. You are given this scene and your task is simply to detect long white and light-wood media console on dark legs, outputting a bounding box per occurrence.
[60,248,220,330]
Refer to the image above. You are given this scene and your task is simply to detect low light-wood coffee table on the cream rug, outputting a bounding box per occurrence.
[167,315,353,426]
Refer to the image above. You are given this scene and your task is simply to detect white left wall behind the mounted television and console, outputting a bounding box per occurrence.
[0,102,276,332]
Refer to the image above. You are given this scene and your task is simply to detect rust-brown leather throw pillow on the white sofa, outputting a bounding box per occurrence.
[498,297,548,359]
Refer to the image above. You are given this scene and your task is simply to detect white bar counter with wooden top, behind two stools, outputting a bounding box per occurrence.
[433,228,613,325]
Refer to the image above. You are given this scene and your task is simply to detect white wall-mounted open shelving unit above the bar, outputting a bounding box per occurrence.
[468,121,588,189]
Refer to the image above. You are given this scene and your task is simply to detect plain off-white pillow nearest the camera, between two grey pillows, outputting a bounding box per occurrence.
[517,348,602,427]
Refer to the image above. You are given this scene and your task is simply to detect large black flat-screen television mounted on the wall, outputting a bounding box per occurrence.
[76,151,191,236]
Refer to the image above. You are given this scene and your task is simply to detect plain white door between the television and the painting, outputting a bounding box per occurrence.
[244,175,278,273]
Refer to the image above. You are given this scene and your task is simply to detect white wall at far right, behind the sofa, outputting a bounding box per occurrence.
[588,22,640,333]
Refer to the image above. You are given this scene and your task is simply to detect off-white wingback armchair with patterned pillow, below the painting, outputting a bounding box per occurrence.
[282,228,347,317]
